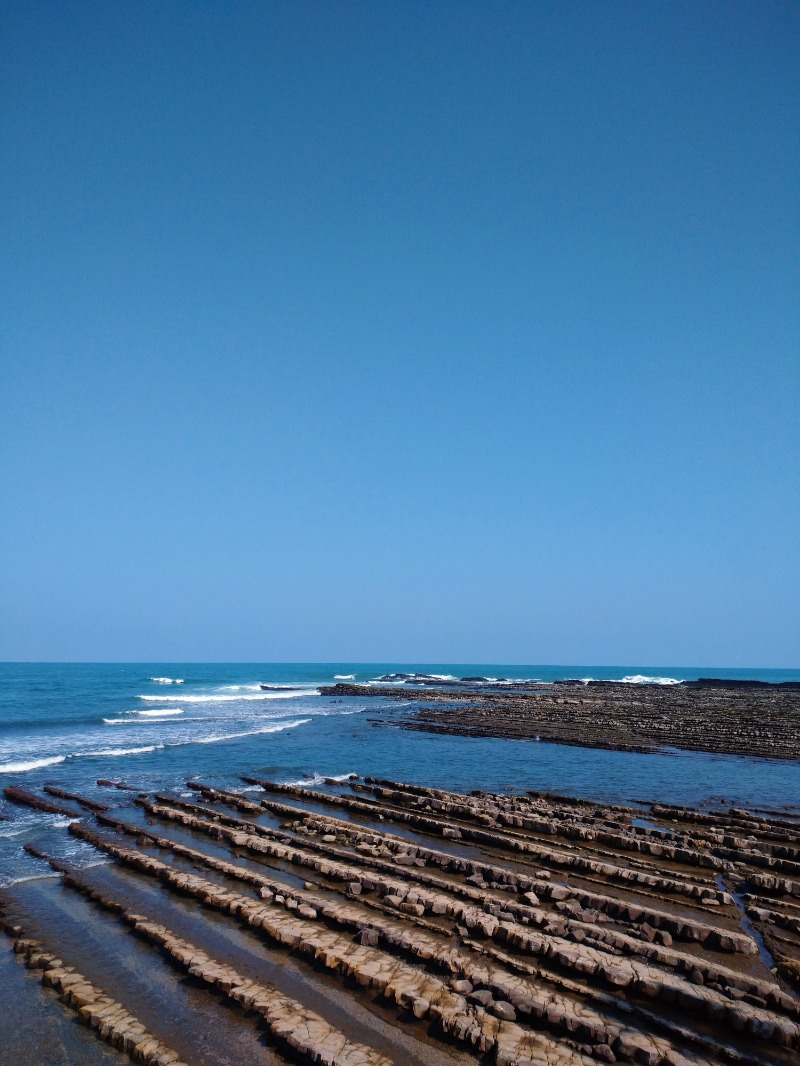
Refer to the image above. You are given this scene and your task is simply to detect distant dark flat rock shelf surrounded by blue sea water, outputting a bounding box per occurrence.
[320,678,800,759]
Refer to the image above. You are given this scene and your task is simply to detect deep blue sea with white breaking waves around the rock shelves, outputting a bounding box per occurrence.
[0,663,800,883]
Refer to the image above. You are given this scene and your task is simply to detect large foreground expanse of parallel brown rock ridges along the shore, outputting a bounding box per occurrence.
[6,778,800,1066]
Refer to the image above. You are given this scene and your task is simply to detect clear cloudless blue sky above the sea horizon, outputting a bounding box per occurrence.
[0,0,800,667]
